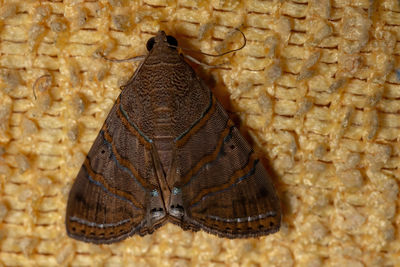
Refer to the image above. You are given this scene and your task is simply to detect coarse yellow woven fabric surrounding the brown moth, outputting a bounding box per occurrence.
[0,0,400,267]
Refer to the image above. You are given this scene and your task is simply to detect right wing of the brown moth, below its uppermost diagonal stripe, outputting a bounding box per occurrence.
[169,97,281,238]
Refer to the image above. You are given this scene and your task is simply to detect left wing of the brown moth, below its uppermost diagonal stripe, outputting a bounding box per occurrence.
[66,98,167,243]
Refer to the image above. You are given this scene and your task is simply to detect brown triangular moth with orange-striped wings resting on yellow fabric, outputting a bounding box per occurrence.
[66,31,281,243]
